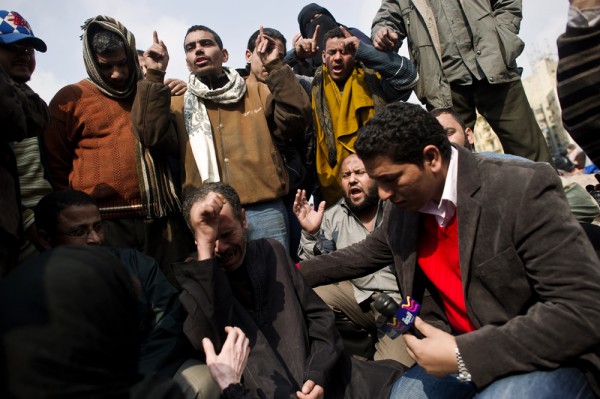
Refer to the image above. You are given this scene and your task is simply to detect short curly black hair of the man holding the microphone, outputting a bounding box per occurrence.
[354,102,451,168]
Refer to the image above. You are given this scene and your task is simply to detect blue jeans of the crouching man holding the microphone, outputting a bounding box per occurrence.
[390,365,595,399]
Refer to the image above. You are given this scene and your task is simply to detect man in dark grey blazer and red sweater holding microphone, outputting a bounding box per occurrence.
[300,103,600,398]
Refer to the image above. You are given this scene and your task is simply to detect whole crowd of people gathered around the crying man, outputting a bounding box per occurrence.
[0,0,600,399]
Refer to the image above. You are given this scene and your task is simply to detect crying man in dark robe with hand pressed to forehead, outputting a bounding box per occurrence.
[175,182,402,399]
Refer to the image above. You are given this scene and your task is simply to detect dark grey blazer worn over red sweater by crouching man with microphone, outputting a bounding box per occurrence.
[300,148,600,394]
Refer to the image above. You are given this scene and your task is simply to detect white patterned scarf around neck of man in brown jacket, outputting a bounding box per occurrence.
[183,67,246,183]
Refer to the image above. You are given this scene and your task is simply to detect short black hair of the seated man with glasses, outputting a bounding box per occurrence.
[33,190,98,234]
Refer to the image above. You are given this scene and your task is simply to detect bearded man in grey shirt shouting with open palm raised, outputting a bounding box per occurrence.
[294,154,413,366]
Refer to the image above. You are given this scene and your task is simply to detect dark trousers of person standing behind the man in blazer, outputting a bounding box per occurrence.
[451,79,554,165]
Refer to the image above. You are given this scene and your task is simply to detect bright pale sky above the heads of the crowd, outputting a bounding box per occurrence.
[1,0,568,101]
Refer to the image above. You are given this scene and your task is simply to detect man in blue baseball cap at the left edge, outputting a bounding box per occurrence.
[0,10,48,277]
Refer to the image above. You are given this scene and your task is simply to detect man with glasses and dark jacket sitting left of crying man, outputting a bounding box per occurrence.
[35,190,219,398]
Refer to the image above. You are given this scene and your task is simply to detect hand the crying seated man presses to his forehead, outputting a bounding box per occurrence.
[190,192,226,260]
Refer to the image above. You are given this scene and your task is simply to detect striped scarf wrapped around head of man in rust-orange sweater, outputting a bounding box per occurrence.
[81,15,181,219]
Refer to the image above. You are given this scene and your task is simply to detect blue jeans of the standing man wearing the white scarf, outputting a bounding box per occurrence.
[244,200,290,253]
